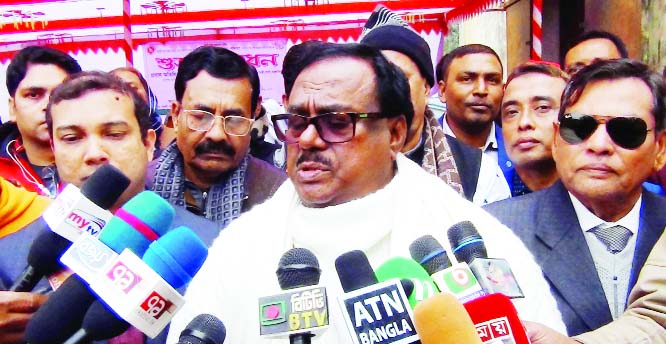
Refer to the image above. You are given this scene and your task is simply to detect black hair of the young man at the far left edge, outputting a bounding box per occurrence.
[5,45,81,97]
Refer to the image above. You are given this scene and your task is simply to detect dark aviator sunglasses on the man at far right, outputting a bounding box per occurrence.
[559,113,654,149]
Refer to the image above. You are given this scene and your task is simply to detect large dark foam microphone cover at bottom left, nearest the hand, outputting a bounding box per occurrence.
[24,275,96,344]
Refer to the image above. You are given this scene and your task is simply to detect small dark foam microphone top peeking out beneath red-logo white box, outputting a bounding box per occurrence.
[81,300,130,340]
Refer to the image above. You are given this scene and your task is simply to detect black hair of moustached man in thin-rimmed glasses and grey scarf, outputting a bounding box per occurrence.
[174,46,260,113]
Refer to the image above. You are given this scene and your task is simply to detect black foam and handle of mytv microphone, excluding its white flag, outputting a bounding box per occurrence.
[9,164,130,292]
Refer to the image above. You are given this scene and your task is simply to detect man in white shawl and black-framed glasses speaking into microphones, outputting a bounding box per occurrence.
[168,43,564,344]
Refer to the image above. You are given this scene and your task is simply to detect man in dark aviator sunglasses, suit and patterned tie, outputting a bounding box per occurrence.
[485,59,666,335]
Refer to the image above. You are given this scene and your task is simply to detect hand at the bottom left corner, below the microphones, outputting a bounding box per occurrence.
[0,291,48,344]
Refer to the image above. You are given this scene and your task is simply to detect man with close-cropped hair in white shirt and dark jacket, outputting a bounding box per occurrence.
[436,44,511,205]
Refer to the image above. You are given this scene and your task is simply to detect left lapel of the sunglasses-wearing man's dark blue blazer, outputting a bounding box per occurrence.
[535,182,612,329]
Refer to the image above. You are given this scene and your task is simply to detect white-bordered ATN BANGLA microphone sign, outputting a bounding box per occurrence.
[339,279,419,344]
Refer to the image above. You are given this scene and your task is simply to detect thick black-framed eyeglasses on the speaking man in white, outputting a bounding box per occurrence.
[271,112,384,143]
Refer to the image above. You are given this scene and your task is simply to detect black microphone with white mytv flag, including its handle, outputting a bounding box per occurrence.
[9,164,130,292]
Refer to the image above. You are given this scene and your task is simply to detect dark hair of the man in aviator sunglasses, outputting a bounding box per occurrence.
[559,59,666,131]
